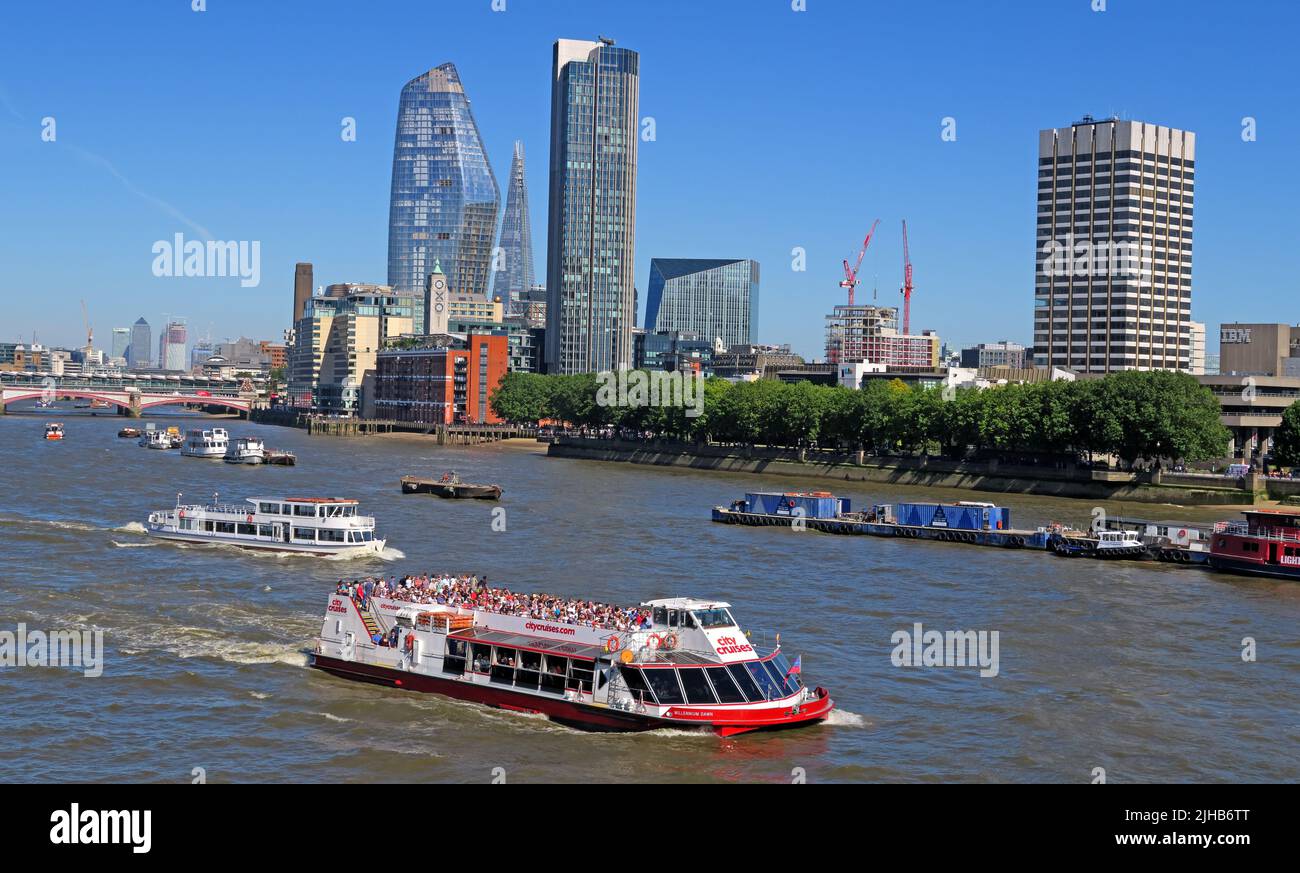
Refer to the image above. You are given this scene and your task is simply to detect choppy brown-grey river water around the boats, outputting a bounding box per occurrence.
[0,409,1300,782]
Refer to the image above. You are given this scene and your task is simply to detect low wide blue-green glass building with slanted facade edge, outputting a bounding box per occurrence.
[646,257,758,348]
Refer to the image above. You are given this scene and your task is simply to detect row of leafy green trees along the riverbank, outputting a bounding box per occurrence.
[491,370,1230,464]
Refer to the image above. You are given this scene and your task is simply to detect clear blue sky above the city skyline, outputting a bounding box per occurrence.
[0,0,1300,356]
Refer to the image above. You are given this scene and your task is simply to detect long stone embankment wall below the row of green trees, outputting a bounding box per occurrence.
[547,437,1258,505]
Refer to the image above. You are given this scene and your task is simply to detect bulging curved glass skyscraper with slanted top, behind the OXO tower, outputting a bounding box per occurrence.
[389,64,501,334]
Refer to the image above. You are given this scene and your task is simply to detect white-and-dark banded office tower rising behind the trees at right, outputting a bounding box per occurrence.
[1034,117,1196,373]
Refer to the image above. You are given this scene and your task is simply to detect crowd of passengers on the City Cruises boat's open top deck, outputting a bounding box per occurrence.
[335,573,651,633]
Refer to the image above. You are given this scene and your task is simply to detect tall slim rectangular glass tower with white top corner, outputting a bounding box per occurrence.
[546,39,640,373]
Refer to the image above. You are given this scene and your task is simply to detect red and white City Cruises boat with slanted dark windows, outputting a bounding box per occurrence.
[312,594,835,737]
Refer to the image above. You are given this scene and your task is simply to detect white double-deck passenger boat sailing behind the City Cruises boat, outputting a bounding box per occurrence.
[146,495,385,555]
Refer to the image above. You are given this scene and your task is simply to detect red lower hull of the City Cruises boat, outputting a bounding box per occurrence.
[312,653,835,737]
